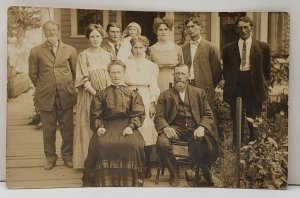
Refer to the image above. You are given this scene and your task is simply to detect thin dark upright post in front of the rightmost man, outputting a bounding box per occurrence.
[235,97,242,188]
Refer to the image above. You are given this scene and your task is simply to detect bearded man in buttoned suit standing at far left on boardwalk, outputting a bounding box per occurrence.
[29,21,77,170]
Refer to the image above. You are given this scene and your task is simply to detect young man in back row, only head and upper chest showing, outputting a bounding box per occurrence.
[101,22,121,59]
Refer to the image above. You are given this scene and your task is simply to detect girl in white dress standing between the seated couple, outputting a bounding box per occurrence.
[125,36,160,178]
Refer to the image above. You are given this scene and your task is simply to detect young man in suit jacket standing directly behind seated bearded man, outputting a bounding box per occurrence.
[182,16,222,105]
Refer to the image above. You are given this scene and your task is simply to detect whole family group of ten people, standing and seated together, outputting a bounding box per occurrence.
[29,16,270,186]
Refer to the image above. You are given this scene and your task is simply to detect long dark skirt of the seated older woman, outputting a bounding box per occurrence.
[83,118,145,186]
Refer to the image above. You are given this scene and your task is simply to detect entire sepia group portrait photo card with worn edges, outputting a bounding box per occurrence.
[6,6,290,189]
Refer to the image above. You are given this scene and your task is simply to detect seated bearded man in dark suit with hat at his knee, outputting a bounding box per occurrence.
[154,64,218,186]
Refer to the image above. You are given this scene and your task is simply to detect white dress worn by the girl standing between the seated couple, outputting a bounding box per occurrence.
[125,57,160,146]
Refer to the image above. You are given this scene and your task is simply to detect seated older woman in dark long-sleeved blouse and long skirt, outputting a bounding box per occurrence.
[83,60,145,186]
